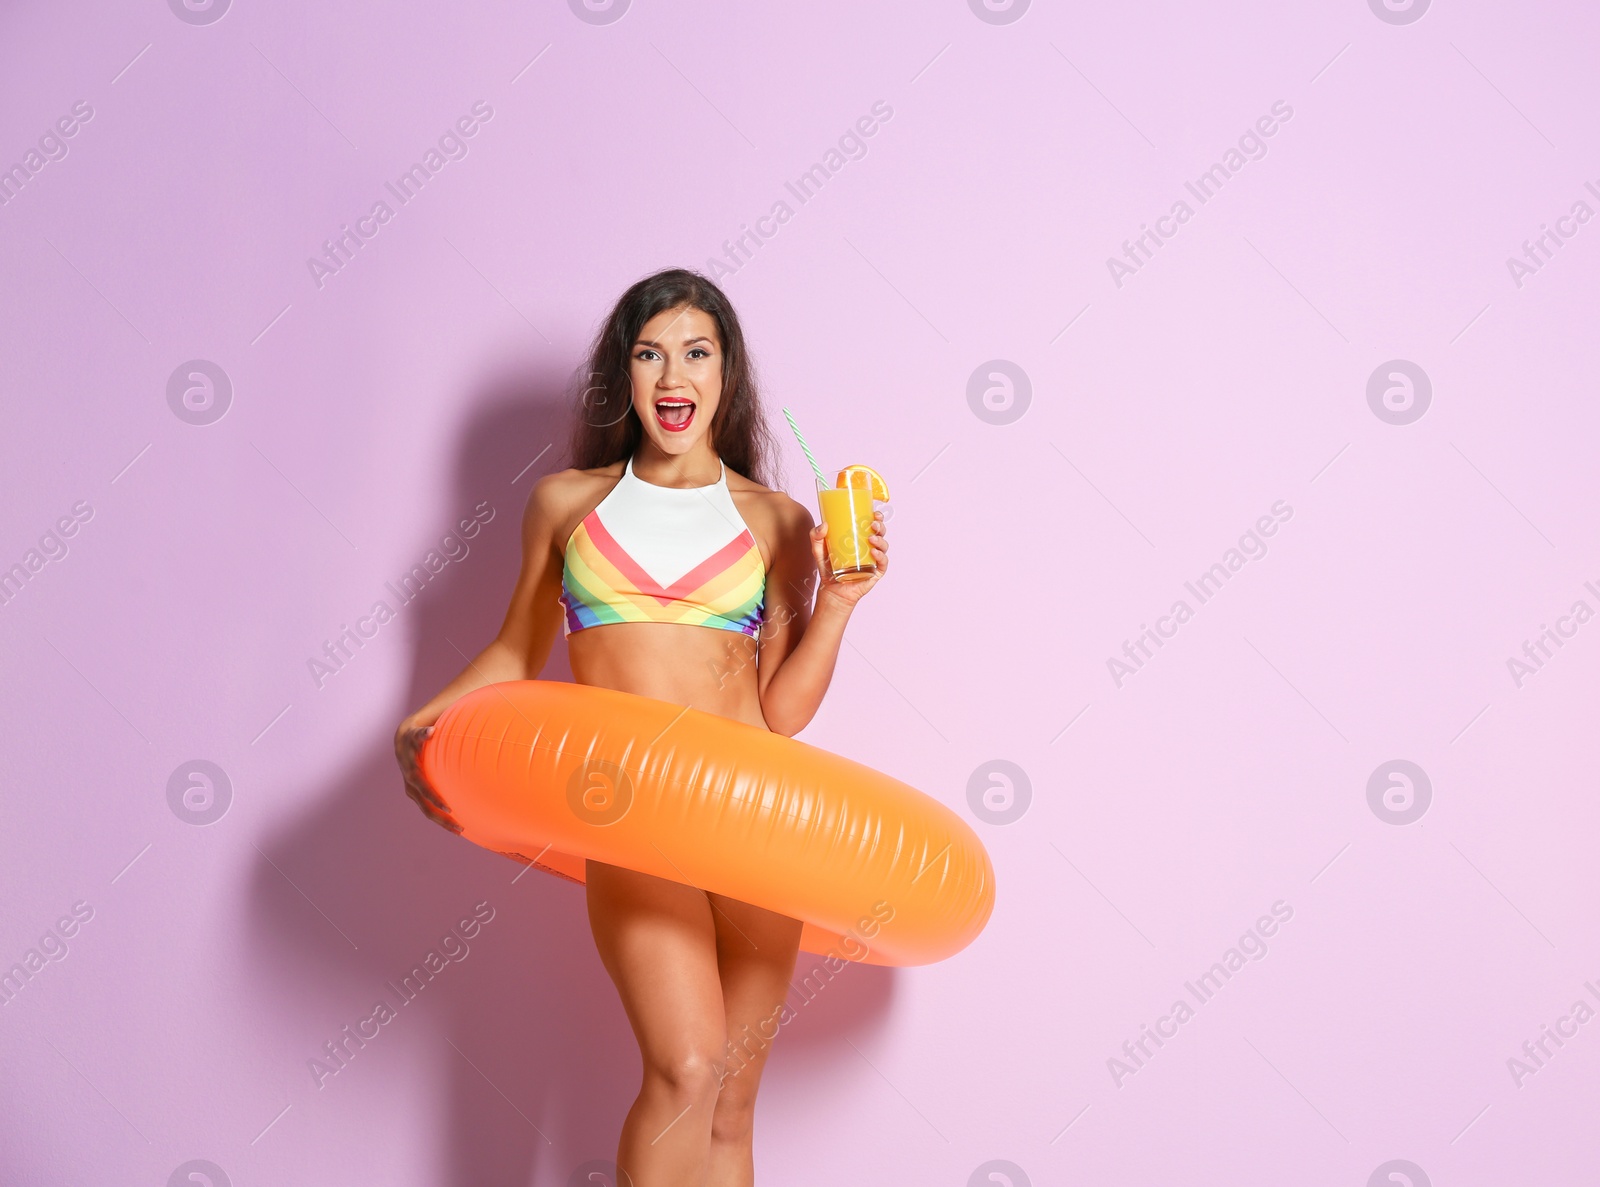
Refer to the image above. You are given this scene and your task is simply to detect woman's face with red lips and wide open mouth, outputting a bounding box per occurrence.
[629,306,722,456]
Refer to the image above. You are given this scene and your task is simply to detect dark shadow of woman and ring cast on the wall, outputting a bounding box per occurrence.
[248,371,893,1187]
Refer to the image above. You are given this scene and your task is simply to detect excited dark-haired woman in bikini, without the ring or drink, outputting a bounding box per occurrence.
[395,269,888,1187]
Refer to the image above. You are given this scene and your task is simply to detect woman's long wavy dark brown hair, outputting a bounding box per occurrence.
[570,267,778,488]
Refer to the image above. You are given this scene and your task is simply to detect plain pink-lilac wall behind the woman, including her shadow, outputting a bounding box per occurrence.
[0,0,1600,1187]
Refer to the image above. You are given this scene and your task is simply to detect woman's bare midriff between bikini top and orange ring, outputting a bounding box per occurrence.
[566,622,768,729]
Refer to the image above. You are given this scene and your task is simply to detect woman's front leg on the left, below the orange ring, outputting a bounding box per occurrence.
[584,861,728,1187]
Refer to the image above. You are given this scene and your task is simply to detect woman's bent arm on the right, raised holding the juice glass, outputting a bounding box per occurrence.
[757,501,890,737]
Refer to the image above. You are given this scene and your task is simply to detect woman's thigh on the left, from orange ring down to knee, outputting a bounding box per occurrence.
[584,861,726,1075]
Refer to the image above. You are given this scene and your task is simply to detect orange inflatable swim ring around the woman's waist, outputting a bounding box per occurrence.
[418,680,994,965]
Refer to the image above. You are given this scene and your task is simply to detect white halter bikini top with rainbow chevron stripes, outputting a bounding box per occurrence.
[562,458,766,637]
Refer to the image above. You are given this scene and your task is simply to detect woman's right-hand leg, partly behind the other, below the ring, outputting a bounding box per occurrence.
[706,894,800,1187]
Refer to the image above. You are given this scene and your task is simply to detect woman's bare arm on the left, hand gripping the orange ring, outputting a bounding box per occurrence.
[395,474,566,832]
